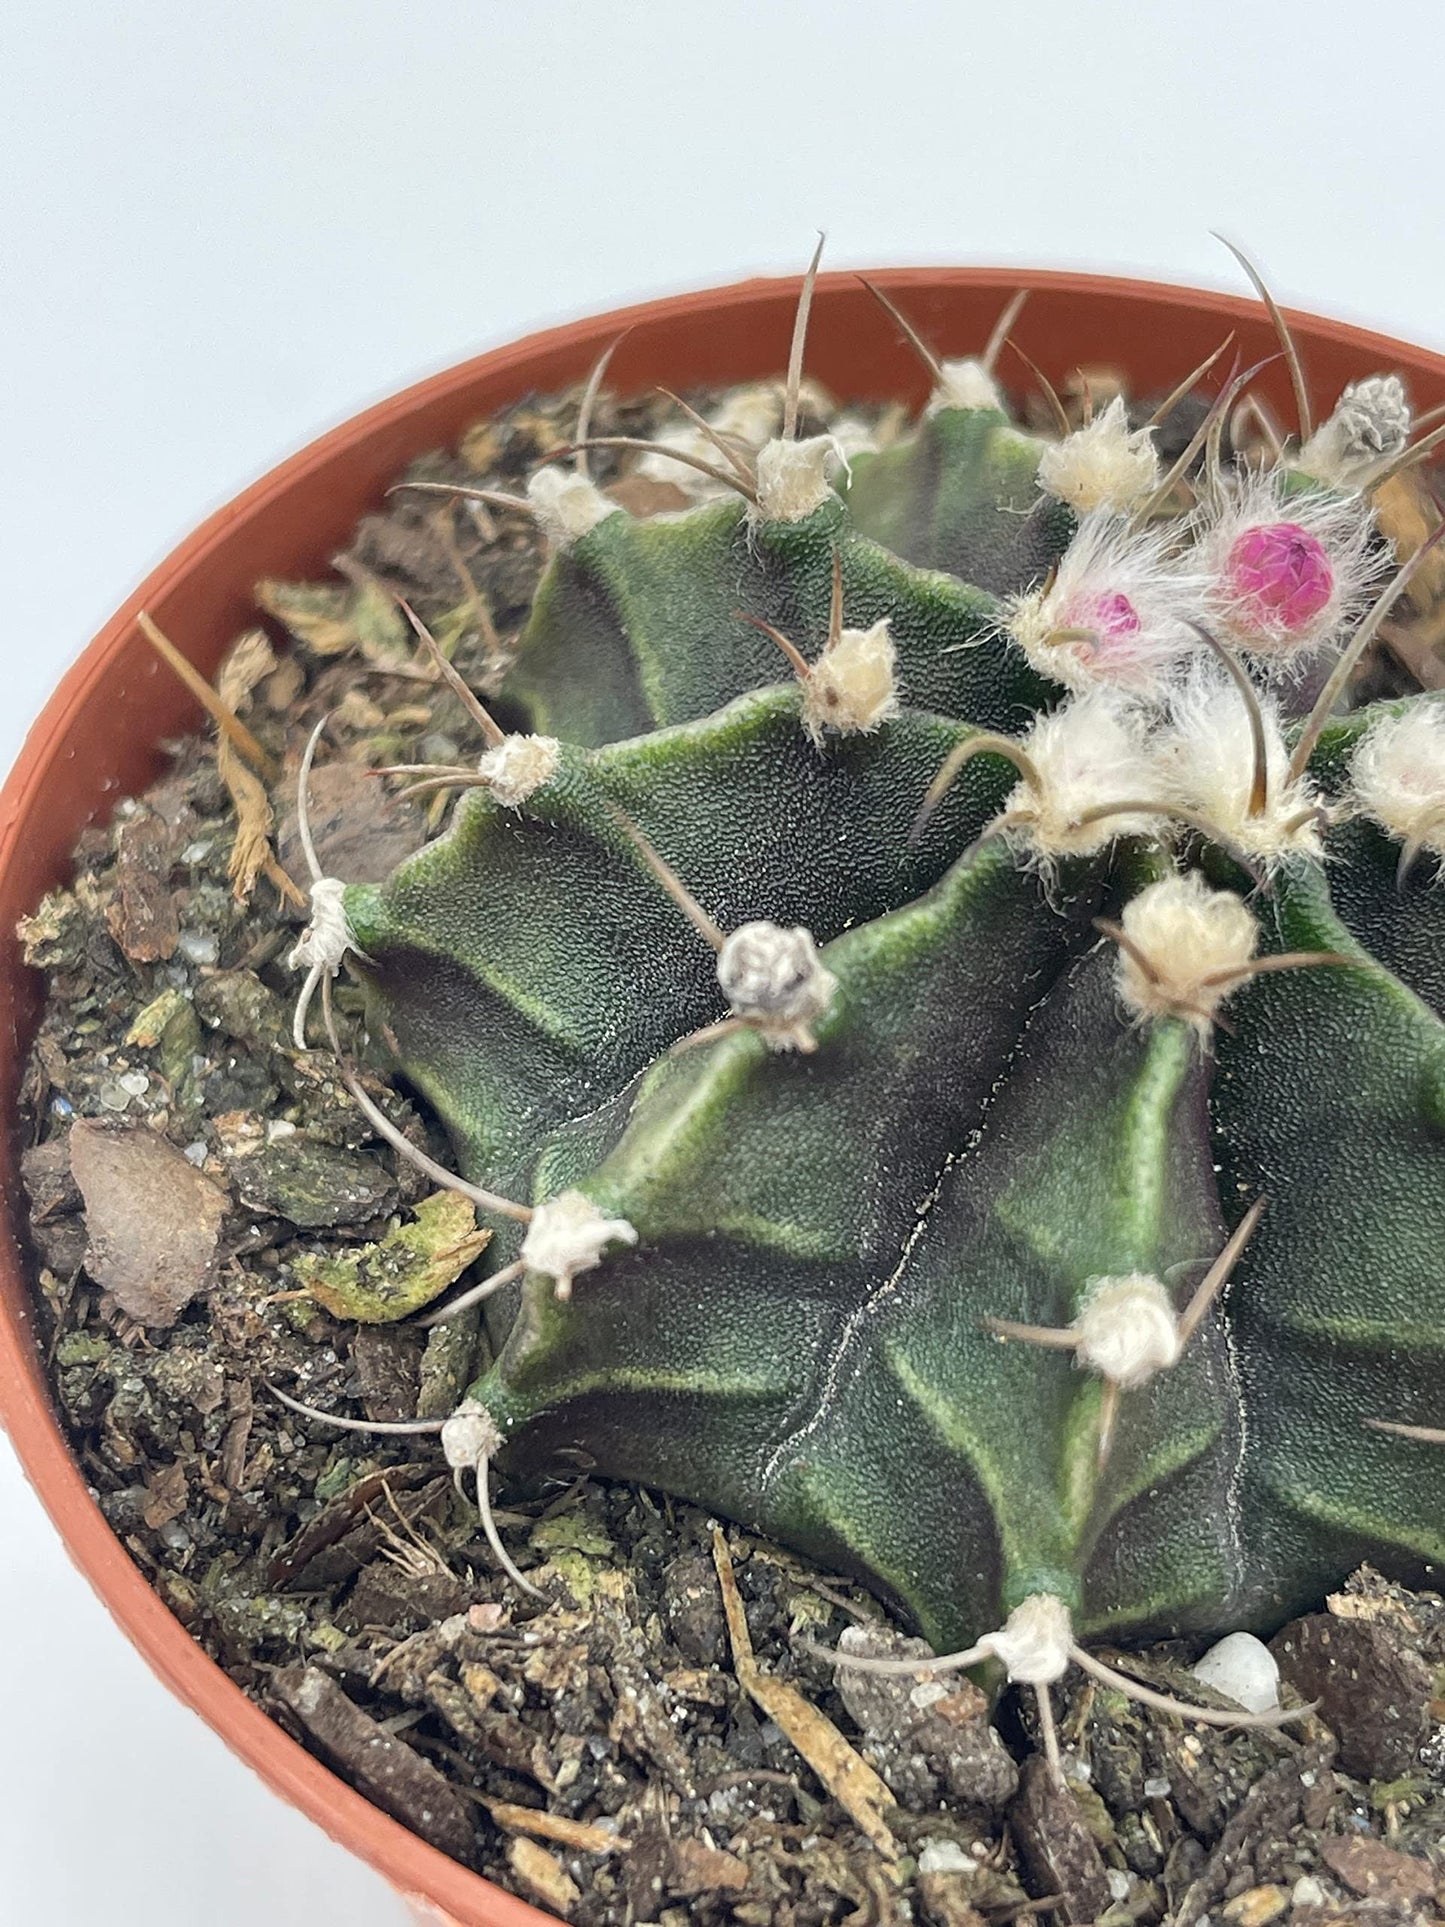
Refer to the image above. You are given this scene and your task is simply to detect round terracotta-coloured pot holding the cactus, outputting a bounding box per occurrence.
[0,268,1445,1927]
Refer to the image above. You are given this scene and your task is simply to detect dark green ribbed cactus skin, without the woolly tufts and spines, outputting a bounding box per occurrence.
[349,398,1445,1646]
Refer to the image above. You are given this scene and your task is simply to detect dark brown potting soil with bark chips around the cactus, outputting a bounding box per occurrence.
[14,379,1445,1927]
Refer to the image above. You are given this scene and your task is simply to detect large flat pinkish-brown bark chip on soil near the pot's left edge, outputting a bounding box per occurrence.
[69,1118,227,1326]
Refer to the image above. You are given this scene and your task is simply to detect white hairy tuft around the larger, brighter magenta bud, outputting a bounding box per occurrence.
[1191,470,1389,665]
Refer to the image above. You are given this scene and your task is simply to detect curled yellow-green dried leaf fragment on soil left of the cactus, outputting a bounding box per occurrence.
[295,1191,491,1324]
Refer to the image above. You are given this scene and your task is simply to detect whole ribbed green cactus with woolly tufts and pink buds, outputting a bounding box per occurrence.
[285,267,1445,1734]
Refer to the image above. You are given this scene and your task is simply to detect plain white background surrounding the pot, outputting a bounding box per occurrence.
[0,0,1445,1927]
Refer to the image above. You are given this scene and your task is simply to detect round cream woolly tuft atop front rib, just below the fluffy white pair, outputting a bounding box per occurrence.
[1116,871,1260,1035]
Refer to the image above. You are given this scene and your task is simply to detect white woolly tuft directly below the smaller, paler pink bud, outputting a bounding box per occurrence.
[1004,692,1164,858]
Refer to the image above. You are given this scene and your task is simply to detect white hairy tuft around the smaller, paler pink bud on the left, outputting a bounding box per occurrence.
[1006,511,1208,698]
